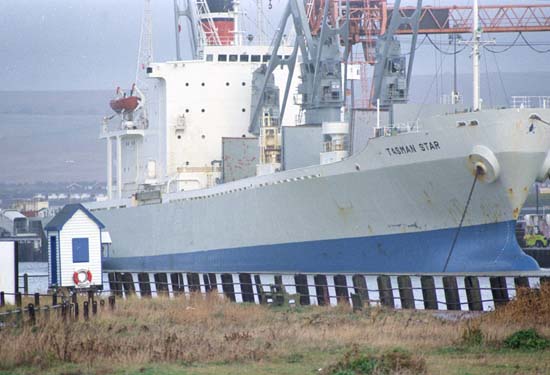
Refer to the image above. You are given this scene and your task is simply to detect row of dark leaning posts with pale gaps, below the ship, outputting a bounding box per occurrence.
[103,272,550,311]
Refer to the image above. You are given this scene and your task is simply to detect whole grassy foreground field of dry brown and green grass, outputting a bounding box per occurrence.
[0,285,550,375]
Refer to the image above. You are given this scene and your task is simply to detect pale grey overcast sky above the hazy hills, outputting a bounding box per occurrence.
[0,0,550,90]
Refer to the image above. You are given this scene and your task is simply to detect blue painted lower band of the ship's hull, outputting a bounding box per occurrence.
[103,221,539,273]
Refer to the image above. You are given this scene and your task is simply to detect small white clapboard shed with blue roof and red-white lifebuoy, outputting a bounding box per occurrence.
[45,204,105,289]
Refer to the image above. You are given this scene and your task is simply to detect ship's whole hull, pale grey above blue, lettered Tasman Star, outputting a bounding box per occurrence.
[89,109,550,273]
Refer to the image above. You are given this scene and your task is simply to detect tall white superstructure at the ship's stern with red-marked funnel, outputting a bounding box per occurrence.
[100,2,299,200]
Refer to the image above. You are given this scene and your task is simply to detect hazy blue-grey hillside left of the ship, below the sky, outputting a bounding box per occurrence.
[0,90,112,183]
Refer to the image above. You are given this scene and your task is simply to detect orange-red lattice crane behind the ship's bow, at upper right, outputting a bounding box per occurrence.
[306,0,550,107]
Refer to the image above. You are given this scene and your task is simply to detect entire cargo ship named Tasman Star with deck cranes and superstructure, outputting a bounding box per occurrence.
[87,0,550,273]
